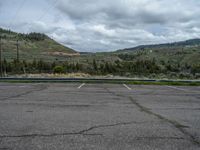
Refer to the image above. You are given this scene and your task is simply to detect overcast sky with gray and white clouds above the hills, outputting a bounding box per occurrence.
[0,0,200,52]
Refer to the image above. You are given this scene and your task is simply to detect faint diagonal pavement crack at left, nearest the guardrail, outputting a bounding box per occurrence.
[0,85,48,101]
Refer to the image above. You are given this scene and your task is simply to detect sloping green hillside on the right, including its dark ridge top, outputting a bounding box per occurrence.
[115,39,200,66]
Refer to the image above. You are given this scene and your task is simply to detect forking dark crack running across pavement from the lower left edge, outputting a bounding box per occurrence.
[0,121,141,139]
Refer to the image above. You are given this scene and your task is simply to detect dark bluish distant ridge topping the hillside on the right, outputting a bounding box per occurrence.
[117,39,200,52]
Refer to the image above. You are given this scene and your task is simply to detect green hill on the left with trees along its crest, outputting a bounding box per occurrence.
[0,28,79,61]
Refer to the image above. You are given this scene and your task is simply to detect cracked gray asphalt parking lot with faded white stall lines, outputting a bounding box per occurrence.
[0,83,200,150]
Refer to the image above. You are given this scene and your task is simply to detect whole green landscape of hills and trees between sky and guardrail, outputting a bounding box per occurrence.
[1,29,200,79]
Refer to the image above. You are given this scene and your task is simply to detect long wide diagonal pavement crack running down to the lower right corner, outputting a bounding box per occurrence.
[105,88,200,147]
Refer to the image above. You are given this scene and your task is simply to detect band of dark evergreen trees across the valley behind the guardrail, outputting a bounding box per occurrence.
[2,59,200,78]
